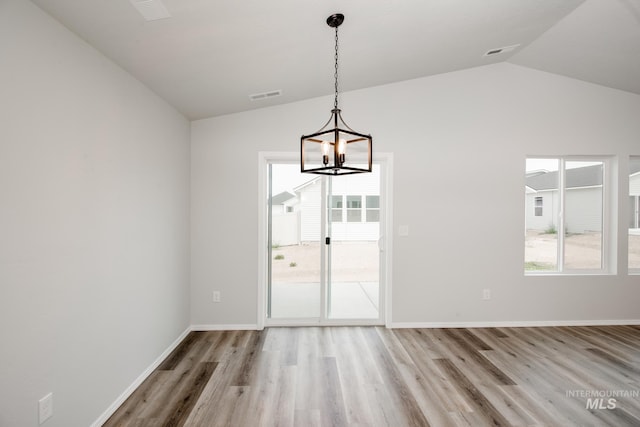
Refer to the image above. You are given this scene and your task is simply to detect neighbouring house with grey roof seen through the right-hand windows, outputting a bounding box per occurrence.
[525,163,640,233]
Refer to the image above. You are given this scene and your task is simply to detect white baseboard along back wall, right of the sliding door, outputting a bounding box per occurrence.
[389,319,640,329]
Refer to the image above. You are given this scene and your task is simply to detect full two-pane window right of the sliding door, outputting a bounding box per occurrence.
[525,157,611,274]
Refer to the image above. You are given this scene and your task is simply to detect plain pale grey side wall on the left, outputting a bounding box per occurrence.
[0,0,190,427]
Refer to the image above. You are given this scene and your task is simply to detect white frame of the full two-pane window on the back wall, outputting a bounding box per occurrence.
[522,155,617,276]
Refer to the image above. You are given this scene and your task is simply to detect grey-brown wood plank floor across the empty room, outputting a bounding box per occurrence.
[105,326,640,427]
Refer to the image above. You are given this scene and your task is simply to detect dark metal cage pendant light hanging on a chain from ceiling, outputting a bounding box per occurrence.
[300,13,373,176]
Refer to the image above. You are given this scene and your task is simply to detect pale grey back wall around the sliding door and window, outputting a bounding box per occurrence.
[191,63,640,324]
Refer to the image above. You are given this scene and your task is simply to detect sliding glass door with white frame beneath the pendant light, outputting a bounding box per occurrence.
[266,161,384,324]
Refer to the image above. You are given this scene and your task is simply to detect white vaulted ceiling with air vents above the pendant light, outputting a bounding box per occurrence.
[32,0,640,119]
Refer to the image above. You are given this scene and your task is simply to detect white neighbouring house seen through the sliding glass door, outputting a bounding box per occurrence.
[272,169,380,246]
